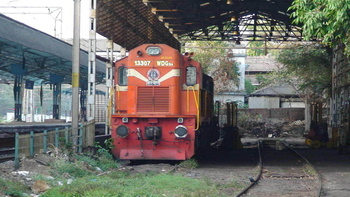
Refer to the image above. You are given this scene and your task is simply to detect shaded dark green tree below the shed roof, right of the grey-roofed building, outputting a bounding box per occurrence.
[275,44,332,99]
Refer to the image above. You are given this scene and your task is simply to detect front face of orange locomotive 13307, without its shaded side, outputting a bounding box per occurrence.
[111,44,196,160]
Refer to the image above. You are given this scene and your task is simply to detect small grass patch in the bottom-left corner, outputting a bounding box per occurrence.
[0,178,30,197]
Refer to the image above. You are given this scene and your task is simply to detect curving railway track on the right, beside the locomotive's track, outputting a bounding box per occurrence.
[237,140,322,197]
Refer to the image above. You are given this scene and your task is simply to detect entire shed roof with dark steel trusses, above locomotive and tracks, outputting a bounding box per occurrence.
[97,0,302,50]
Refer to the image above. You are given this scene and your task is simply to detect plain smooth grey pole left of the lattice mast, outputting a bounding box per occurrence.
[72,0,81,150]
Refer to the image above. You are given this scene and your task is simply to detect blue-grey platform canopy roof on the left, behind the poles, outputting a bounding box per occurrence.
[0,14,105,85]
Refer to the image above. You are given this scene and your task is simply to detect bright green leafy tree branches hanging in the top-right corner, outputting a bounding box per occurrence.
[290,0,350,56]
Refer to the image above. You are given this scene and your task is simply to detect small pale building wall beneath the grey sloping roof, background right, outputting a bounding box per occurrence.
[248,96,280,109]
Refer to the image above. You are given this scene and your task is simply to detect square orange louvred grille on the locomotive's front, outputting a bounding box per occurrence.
[137,86,169,112]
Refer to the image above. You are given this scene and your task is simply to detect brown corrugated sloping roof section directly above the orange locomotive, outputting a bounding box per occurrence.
[96,0,180,50]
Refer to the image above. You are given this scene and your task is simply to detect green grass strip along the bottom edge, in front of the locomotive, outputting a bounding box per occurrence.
[42,174,227,197]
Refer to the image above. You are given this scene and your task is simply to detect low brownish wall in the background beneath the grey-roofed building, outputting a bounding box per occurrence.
[238,108,305,123]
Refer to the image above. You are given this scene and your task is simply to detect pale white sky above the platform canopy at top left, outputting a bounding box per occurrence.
[0,0,90,39]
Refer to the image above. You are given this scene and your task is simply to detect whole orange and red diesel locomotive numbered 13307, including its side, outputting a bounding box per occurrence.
[111,44,216,160]
